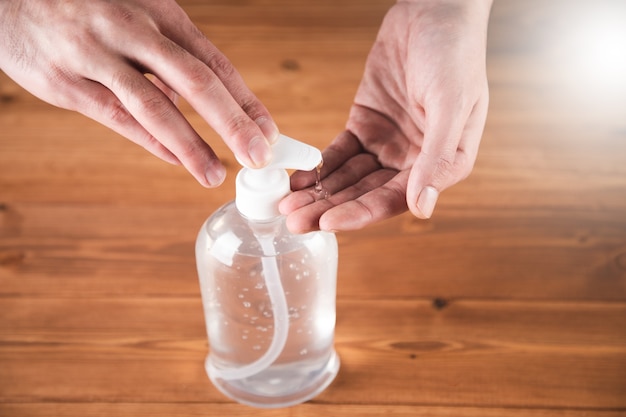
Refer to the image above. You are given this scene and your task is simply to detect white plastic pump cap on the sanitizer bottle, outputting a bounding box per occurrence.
[235,135,322,221]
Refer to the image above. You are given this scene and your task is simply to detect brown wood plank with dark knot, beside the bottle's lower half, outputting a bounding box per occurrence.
[0,297,626,409]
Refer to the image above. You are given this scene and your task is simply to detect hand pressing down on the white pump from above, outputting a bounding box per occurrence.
[0,0,278,186]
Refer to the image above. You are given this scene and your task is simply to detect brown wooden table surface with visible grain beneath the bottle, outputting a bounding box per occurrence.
[0,0,626,417]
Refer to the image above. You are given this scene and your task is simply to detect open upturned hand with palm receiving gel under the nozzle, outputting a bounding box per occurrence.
[280,0,491,232]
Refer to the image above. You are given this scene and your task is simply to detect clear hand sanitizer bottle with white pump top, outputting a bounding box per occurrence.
[196,135,339,408]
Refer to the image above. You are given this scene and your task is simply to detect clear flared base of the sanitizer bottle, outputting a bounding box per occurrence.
[205,350,340,408]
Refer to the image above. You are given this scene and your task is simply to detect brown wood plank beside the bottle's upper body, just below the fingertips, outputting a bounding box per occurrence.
[0,204,626,301]
